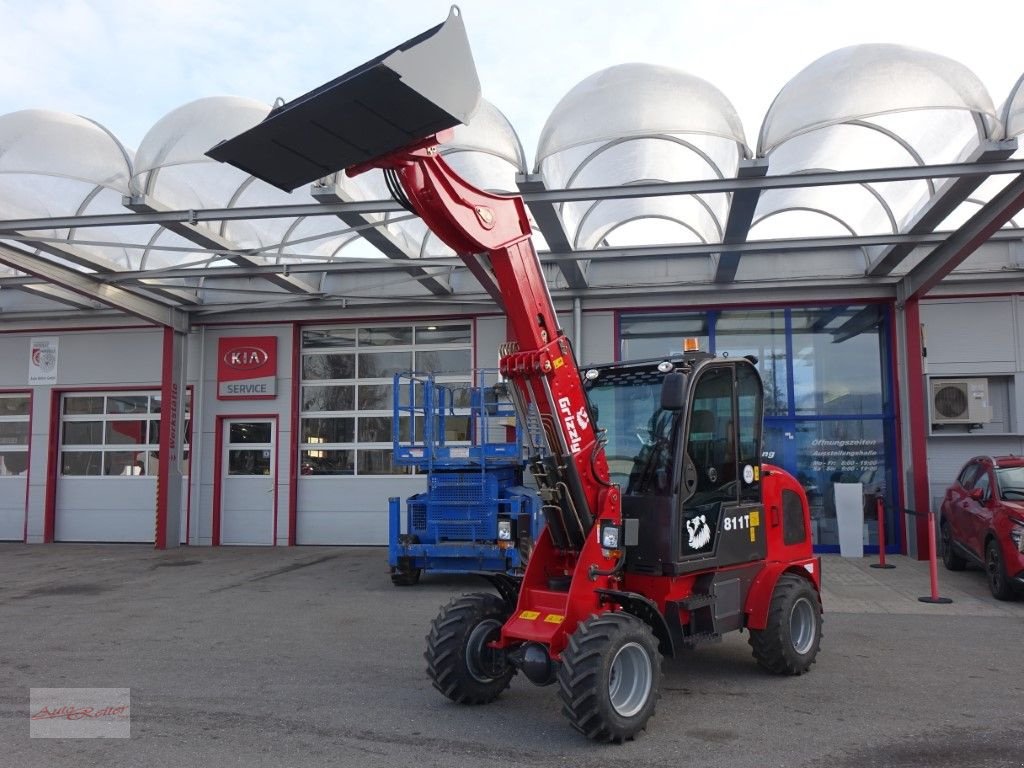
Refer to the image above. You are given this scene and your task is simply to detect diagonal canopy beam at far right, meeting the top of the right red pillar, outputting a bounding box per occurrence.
[896,173,1024,303]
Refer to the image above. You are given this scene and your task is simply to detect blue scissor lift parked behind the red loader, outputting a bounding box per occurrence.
[388,372,542,587]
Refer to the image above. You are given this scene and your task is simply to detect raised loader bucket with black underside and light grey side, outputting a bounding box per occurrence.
[207,6,480,191]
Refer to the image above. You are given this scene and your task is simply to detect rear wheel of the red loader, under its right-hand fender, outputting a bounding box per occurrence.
[750,573,821,675]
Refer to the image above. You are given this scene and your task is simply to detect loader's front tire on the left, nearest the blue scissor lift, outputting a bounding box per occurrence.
[423,593,515,705]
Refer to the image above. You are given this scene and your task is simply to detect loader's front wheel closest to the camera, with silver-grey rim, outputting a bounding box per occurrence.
[558,612,662,742]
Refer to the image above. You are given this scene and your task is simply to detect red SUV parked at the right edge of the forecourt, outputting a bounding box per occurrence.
[940,456,1024,600]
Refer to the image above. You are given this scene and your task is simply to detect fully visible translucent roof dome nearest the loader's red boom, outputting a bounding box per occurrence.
[536,63,750,249]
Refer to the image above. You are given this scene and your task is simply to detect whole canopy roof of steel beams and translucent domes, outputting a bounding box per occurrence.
[0,45,1024,331]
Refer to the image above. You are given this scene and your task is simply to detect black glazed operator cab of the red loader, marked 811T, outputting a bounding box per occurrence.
[585,352,766,574]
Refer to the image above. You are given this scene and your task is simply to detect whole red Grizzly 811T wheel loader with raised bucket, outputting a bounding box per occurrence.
[208,8,821,742]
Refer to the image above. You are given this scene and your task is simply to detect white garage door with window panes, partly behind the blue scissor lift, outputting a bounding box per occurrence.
[296,322,473,545]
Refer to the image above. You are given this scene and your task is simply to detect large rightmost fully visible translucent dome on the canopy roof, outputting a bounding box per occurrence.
[751,44,999,239]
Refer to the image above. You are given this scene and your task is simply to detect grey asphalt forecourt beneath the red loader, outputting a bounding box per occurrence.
[0,545,1024,768]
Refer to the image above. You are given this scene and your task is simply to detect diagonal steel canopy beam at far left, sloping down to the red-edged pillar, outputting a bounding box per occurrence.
[0,245,189,333]
